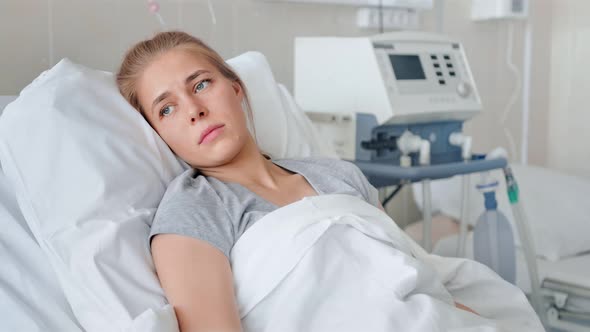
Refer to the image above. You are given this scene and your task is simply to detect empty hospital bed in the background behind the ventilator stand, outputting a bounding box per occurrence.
[406,169,590,331]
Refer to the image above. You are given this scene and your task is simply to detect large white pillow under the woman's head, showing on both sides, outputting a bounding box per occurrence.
[0,52,326,331]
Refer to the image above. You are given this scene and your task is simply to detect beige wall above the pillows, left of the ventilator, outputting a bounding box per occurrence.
[0,0,374,94]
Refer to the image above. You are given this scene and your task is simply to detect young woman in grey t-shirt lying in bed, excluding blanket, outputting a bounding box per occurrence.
[117,32,478,331]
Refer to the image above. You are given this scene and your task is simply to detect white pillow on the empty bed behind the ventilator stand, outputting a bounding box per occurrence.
[414,165,590,260]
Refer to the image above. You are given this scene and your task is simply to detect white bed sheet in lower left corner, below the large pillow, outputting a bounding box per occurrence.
[0,168,82,332]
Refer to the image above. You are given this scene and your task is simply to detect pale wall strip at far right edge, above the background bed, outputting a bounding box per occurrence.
[548,0,590,176]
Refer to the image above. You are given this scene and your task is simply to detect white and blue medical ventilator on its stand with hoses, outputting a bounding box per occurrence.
[294,32,541,322]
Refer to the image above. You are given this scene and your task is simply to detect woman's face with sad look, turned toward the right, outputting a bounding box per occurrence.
[137,48,251,169]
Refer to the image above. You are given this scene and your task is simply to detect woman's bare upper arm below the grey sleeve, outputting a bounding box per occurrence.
[152,234,241,332]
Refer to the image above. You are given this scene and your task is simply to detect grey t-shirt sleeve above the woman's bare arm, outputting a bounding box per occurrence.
[150,174,234,258]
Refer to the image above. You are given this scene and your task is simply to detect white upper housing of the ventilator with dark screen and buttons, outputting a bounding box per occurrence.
[294,32,482,125]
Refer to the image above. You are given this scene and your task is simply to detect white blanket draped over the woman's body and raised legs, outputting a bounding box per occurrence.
[231,195,543,332]
